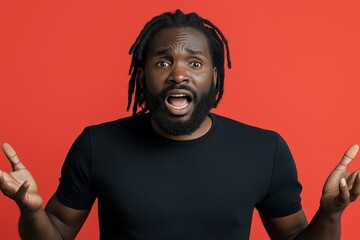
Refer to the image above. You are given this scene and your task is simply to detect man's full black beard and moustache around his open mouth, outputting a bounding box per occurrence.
[144,81,217,136]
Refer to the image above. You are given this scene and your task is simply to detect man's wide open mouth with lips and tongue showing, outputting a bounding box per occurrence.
[165,90,193,115]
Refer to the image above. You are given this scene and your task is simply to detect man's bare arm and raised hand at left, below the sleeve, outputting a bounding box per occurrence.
[0,143,90,240]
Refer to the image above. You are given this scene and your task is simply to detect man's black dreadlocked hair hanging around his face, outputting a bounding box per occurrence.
[127,10,231,115]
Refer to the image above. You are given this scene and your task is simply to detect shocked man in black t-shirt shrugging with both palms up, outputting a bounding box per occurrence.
[0,10,360,240]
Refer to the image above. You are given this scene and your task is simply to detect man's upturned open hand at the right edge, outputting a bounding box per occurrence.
[320,144,360,214]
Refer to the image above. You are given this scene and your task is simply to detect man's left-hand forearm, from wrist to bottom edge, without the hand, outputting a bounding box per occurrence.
[19,208,62,240]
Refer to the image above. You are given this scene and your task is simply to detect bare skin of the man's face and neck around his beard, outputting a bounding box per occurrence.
[140,28,217,140]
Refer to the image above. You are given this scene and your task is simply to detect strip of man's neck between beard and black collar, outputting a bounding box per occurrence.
[151,116,212,141]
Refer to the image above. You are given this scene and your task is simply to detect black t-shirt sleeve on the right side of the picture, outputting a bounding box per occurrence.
[257,135,302,217]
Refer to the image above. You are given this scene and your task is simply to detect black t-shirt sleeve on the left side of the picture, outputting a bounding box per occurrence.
[56,128,95,210]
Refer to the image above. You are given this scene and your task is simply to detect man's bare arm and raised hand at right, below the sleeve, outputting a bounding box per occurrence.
[260,145,360,240]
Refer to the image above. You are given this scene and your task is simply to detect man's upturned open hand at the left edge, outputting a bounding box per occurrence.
[0,143,42,212]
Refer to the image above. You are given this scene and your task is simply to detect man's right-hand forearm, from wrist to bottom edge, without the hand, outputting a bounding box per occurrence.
[294,209,341,240]
